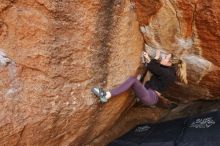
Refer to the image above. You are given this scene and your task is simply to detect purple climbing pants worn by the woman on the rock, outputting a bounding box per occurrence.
[110,77,158,105]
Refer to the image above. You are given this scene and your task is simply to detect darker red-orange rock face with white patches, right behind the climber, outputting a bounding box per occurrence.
[136,0,220,102]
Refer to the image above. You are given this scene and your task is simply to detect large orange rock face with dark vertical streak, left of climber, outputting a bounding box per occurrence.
[0,0,143,146]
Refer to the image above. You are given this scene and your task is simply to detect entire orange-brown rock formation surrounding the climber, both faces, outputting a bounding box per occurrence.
[0,0,220,146]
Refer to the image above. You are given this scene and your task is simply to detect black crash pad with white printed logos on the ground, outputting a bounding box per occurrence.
[108,111,220,146]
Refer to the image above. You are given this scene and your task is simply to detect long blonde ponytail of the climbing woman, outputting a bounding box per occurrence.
[171,54,188,84]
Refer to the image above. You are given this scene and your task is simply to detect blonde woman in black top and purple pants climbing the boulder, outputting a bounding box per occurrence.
[91,50,187,108]
